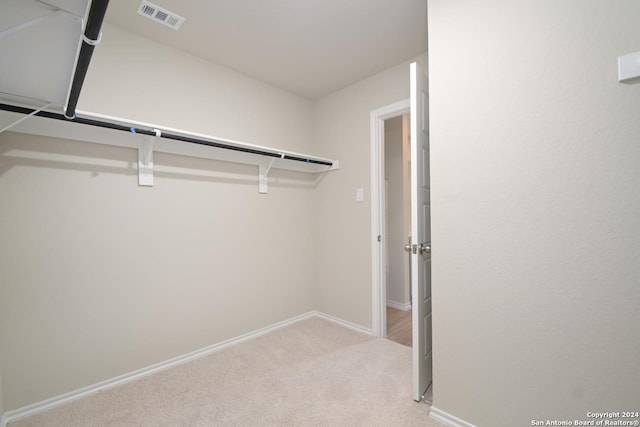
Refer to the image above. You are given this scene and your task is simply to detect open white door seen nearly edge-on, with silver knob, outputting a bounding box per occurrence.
[410,62,432,401]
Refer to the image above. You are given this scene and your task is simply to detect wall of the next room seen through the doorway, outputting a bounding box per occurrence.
[384,116,409,305]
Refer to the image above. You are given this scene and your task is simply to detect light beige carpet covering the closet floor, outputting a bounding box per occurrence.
[10,318,442,427]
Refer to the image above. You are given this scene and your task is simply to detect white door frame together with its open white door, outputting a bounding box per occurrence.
[371,62,433,402]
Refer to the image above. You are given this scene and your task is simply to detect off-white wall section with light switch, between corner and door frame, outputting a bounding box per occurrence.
[314,54,426,328]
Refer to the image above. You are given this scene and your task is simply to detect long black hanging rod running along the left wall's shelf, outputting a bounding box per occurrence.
[0,104,334,166]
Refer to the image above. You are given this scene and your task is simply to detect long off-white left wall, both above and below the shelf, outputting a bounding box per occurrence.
[0,23,316,411]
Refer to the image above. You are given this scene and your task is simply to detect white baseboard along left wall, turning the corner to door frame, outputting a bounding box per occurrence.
[0,311,373,427]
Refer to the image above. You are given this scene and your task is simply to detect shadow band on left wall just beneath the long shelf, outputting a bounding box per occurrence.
[0,132,325,191]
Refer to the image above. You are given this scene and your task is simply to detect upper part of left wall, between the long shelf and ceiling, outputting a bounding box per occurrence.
[78,25,312,152]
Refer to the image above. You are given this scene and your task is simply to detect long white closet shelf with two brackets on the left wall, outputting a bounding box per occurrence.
[0,104,339,193]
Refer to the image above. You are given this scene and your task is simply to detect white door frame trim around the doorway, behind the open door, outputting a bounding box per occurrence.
[370,98,411,338]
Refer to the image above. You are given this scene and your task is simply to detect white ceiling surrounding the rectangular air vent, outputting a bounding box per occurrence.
[106,0,427,98]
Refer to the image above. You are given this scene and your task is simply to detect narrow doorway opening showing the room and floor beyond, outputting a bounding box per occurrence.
[383,113,412,347]
